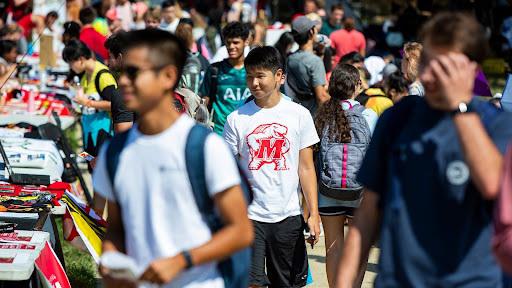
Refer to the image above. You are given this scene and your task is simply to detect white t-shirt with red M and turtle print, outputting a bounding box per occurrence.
[224,99,320,223]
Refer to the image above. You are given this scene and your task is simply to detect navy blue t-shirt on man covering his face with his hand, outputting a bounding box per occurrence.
[358,96,512,287]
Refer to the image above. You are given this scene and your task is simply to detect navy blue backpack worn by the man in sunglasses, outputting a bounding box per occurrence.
[106,125,252,288]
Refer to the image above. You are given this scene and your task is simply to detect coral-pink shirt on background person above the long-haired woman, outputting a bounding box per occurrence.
[330,29,366,63]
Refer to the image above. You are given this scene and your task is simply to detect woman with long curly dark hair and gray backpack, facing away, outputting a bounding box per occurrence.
[315,64,377,287]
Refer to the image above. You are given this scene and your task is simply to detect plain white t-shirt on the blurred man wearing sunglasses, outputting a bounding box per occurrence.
[93,115,240,288]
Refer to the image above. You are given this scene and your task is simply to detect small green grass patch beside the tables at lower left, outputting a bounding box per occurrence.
[56,219,99,288]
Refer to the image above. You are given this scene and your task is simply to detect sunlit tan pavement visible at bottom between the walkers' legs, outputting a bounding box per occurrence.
[307,236,379,288]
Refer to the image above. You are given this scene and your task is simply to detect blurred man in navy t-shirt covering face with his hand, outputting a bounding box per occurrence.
[337,13,512,287]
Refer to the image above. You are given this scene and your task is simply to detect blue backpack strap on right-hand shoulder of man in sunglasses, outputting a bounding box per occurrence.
[185,124,217,231]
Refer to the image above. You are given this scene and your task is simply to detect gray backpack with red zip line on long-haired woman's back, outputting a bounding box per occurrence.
[317,101,371,201]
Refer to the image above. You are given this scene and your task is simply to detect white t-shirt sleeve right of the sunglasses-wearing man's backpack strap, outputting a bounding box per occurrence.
[205,133,241,196]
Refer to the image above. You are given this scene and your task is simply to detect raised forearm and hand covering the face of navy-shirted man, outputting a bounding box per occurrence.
[422,53,503,199]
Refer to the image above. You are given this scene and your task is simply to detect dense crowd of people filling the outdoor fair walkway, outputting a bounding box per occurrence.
[0,0,512,287]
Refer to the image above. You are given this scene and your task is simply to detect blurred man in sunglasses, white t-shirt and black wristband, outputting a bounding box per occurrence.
[93,30,253,288]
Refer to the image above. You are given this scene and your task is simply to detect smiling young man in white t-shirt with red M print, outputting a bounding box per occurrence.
[224,46,320,287]
